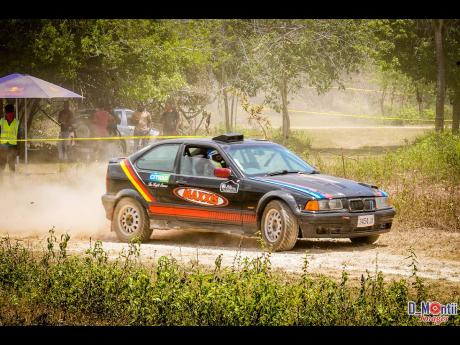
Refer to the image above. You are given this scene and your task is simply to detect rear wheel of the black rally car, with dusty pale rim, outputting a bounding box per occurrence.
[112,197,153,242]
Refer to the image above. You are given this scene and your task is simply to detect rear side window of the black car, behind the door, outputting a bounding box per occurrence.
[136,144,180,172]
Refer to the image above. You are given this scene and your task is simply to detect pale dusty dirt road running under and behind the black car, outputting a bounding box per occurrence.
[0,165,460,284]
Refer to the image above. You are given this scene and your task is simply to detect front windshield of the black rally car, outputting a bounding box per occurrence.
[225,144,315,176]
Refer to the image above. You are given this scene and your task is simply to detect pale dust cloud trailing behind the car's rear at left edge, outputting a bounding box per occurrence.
[0,163,113,239]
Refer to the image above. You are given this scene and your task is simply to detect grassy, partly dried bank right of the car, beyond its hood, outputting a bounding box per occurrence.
[312,133,460,231]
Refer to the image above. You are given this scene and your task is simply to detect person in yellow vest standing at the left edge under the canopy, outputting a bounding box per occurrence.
[0,104,21,173]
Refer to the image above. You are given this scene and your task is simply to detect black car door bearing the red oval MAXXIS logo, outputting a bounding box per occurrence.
[167,145,242,225]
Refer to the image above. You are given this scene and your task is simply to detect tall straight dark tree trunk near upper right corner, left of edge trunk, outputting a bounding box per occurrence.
[434,19,446,132]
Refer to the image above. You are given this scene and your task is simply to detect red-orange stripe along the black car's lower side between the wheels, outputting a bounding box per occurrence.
[149,205,256,224]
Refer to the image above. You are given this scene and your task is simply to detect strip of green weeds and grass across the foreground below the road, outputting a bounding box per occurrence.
[0,230,460,325]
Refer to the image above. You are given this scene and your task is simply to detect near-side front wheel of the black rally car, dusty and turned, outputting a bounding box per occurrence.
[261,200,299,252]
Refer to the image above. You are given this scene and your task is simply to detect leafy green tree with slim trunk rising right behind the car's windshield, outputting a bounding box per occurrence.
[241,20,365,139]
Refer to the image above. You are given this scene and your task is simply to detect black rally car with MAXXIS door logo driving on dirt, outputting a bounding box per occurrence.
[102,134,395,251]
